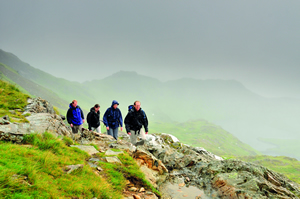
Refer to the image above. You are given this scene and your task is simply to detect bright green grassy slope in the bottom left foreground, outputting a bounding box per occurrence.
[0,133,122,198]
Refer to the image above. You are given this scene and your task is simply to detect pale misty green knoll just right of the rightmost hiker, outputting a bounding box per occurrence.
[149,120,261,156]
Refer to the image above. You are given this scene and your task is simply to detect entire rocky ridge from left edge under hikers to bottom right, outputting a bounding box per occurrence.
[0,98,300,199]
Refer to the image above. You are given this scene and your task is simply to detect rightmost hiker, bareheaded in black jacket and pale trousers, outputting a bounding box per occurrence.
[124,101,148,146]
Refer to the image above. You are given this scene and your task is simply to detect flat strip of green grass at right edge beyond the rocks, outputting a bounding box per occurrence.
[230,155,300,184]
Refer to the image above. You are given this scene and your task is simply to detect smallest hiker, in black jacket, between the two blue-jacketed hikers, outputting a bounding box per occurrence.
[86,104,101,133]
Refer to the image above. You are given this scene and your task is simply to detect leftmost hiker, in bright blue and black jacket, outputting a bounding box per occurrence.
[67,100,84,134]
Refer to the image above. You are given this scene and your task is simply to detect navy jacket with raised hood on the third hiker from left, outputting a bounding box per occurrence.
[103,100,123,129]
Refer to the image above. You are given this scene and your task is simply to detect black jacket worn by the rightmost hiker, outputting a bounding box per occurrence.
[124,108,148,133]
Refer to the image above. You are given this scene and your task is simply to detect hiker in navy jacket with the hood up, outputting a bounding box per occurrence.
[103,100,123,140]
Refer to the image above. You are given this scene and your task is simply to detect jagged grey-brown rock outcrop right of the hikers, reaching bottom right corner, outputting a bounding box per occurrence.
[106,134,300,199]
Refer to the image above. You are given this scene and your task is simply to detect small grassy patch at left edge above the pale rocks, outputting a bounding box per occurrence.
[0,80,30,122]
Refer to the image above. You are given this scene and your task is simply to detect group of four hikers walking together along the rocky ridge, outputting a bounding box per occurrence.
[67,100,148,146]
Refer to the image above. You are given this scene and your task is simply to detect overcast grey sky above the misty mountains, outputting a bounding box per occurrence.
[0,0,300,98]
